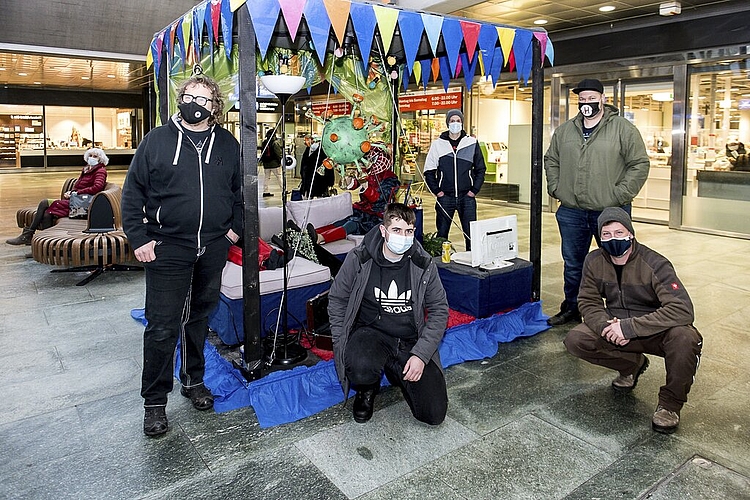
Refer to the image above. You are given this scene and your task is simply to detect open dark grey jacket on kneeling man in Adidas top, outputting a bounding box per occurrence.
[328,226,448,396]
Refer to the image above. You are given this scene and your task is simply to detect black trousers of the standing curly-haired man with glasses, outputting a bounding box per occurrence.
[141,238,230,406]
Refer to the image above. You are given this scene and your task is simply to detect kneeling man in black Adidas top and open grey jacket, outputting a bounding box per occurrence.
[328,203,448,425]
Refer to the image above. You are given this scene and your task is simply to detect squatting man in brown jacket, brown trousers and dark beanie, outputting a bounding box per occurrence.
[565,208,703,434]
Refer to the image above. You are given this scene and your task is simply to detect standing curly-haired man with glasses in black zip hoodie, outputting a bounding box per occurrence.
[122,75,242,436]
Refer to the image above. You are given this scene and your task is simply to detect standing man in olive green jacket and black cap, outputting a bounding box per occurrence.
[544,78,650,326]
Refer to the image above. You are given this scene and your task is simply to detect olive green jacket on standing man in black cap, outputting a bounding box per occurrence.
[544,105,650,210]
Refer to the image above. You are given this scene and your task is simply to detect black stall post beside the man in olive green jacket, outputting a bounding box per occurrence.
[529,37,544,302]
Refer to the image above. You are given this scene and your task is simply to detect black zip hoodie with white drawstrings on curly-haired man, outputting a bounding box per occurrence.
[122,114,242,252]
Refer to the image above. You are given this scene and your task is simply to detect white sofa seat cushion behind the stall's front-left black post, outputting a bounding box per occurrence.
[221,257,331,299]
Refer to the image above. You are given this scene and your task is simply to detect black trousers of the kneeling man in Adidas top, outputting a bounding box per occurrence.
[346,327,448,425]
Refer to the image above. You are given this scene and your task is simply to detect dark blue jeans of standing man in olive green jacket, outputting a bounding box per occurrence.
[555,205,631,307]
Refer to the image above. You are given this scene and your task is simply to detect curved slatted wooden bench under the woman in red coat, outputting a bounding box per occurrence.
[31,183,143,286]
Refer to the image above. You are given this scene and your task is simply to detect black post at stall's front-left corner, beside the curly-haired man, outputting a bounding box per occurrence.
[242,7,263,380]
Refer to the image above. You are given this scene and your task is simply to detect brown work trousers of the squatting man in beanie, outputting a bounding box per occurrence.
[563,323,703,413]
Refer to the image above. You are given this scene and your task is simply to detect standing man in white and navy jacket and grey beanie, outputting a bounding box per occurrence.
[424,109,486,250]
